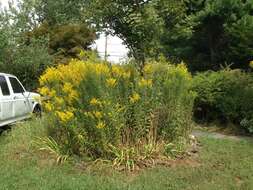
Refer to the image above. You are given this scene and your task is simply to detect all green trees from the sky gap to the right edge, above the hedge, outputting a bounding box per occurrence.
[86,0,253,71]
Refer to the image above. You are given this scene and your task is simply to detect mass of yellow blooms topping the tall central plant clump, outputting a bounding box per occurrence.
[39,60,191,129]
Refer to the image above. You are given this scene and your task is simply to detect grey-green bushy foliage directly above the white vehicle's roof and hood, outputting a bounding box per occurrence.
[0,37,52,90]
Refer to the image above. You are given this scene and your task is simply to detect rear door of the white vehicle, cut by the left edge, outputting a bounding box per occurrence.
[0,75,14,121]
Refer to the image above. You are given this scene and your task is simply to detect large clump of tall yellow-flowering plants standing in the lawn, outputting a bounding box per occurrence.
[40,60,194,167]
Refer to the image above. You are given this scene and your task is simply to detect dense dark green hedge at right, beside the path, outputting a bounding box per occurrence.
[193,69,253,131]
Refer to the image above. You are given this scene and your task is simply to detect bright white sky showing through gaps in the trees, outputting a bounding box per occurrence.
[0,0,128,63]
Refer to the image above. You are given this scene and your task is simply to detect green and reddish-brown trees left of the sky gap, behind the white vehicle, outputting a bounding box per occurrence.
[0,0,96,89]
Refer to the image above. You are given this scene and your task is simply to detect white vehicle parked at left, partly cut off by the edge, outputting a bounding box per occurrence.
[0,73,41,127]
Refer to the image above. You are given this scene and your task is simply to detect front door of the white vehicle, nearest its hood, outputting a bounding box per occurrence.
[9,77,29,118]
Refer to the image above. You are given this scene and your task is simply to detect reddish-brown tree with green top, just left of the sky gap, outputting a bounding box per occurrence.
[24,0,96,63]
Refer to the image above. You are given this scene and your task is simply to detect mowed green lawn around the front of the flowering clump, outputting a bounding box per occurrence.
[0,121,253,190]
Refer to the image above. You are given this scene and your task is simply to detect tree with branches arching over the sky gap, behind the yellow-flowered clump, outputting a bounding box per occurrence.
[87,0,163,70]
